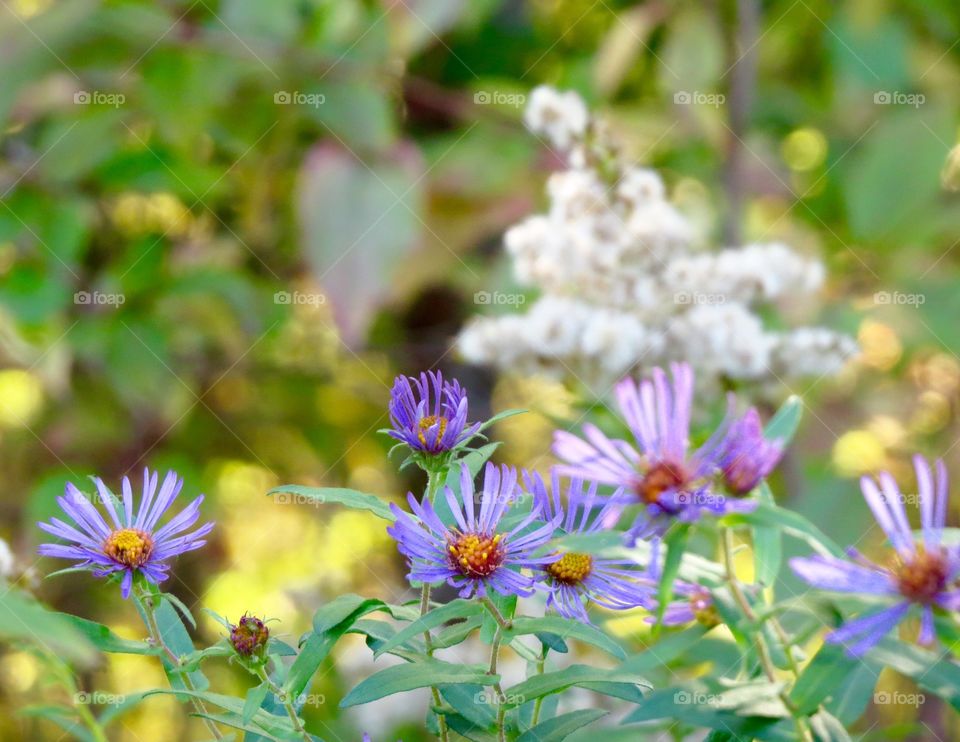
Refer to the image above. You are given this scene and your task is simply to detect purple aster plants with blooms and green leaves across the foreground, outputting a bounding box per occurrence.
[26,368,960,742]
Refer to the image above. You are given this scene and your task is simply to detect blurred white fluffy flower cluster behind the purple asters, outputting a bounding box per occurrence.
[459,87,856,394]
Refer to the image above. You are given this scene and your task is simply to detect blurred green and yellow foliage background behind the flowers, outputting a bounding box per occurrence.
[0,0,960,740]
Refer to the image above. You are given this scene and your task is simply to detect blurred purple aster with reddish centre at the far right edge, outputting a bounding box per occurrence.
[790,455,960,656]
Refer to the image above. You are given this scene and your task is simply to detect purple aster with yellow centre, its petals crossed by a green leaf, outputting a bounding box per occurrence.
[524,474,650,623]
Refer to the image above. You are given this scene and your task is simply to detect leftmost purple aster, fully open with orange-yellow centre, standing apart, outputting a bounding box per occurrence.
[38,469,213,598]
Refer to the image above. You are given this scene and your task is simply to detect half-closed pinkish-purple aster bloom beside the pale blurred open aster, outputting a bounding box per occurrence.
[717,404,783,495]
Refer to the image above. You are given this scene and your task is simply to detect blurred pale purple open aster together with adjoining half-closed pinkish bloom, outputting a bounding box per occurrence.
[553,363,783,539]
